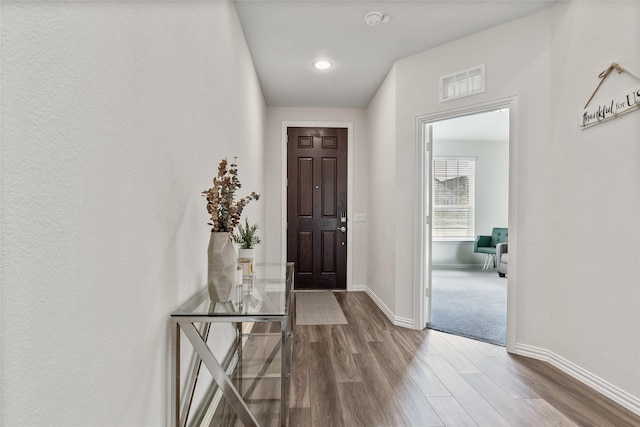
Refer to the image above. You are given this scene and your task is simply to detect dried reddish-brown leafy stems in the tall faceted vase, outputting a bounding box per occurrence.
[202,157,260,233]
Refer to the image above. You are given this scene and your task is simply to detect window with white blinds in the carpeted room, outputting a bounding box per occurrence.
[432,157,476,240]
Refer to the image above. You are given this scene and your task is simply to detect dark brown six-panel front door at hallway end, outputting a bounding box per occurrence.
[287,127,347,289]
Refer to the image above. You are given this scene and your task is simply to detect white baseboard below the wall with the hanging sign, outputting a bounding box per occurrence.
[515,344,640,415]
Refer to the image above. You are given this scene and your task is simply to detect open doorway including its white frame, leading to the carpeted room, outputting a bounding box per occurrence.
[416,97,517,352]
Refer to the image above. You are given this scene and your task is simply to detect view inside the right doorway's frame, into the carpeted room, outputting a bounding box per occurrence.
[429,108,509,346]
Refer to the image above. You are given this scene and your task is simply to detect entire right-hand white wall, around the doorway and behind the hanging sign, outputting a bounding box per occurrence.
[370,1,640,413]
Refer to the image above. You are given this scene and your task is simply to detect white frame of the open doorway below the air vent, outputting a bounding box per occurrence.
[414,95,519,353]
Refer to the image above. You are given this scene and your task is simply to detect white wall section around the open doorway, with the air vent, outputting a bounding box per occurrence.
[370,11,551,330]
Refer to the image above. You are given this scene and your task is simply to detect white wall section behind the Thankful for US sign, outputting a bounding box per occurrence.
[544,2,640,413]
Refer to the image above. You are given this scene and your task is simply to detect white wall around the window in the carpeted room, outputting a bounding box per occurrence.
[431,139,509,267]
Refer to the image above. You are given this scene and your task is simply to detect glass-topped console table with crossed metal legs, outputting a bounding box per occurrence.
[171,263,294,427]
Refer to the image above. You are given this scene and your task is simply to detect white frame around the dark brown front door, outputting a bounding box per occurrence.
[280,120,353,291]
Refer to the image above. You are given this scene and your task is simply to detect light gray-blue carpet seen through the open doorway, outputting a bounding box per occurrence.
[429,268,507,346]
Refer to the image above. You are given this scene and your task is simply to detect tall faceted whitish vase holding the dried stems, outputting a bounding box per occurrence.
[207,232,238,302]
